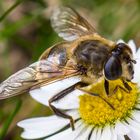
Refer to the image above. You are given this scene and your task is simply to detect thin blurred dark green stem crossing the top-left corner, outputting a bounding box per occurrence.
[0,0,23,22]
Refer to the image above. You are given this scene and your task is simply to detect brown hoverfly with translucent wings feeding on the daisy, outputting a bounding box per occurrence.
[0,7,136,130]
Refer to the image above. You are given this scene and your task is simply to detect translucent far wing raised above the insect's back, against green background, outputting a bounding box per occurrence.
[51,7,96,41]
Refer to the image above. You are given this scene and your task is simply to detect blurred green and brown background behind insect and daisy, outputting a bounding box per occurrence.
[0,0,140,140]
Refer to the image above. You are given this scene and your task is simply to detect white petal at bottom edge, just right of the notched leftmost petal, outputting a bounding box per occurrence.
[45,120,85,140]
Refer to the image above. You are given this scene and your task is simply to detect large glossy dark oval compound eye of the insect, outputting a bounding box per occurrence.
[104,55,122,80]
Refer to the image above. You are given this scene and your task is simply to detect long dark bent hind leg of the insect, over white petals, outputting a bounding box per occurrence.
[49,82,83,130]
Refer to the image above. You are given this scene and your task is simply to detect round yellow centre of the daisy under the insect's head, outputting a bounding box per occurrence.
[79,80,138,126]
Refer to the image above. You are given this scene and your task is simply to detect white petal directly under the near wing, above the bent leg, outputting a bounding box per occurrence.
[30,76,81,106]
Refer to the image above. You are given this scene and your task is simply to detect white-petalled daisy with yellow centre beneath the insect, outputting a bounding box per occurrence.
[18,40,140,140]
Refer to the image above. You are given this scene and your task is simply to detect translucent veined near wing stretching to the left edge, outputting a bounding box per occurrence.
[0,60,77,99]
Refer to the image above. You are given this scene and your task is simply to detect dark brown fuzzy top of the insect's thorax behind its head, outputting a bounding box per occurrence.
[74,39,112,75]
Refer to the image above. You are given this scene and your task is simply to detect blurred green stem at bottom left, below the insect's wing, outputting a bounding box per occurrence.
[0,100,22,140]
